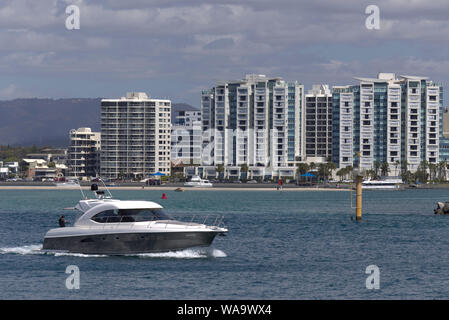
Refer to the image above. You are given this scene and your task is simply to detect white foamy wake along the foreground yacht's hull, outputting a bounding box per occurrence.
[0,244,227,259]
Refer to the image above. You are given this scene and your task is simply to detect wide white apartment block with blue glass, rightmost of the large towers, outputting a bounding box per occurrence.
[332,73,443,171]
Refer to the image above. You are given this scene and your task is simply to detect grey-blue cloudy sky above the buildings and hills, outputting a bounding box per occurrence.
[0,0,449,106]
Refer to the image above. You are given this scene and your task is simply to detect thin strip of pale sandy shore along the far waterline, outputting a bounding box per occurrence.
[0,186,349,192]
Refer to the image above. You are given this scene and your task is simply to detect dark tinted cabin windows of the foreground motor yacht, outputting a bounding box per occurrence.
[92,209,173,223]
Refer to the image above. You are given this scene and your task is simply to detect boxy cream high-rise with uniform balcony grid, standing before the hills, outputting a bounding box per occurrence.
[100,92,171,179]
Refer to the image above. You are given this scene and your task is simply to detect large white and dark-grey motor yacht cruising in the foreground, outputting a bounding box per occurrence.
[42,185,228,255]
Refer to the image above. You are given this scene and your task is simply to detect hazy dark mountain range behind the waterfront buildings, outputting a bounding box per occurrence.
[0,98,197,147]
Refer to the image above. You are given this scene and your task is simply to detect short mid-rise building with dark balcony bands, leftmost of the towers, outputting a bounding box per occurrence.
[67,128,100,179]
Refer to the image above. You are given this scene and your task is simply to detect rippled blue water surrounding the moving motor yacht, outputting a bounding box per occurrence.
[0,190,449,299]
